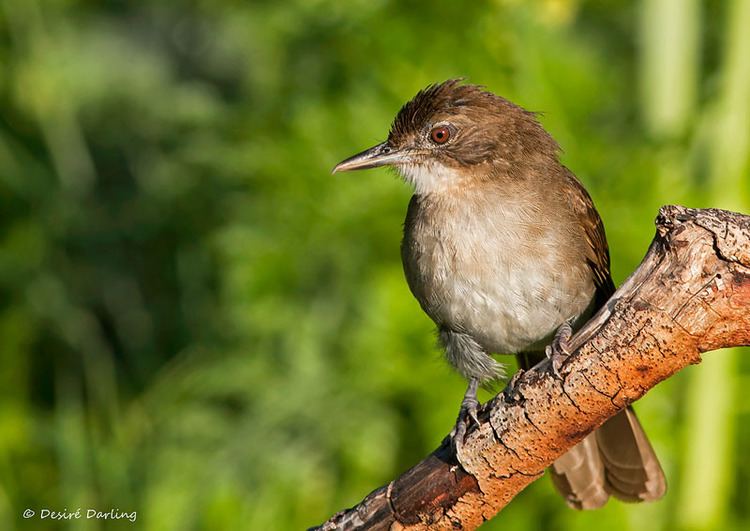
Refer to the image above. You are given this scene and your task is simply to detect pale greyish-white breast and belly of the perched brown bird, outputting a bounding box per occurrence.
[403,185,594,353]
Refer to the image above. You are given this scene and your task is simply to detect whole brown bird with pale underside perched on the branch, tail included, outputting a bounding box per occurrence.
[333,79,666,509]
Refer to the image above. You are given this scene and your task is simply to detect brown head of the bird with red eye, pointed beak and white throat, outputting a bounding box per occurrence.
[333,79,559,193]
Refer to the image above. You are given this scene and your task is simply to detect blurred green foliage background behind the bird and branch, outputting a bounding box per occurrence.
[0,0,750,531]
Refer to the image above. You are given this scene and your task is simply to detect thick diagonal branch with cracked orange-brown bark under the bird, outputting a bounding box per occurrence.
[316,206,750,530]
